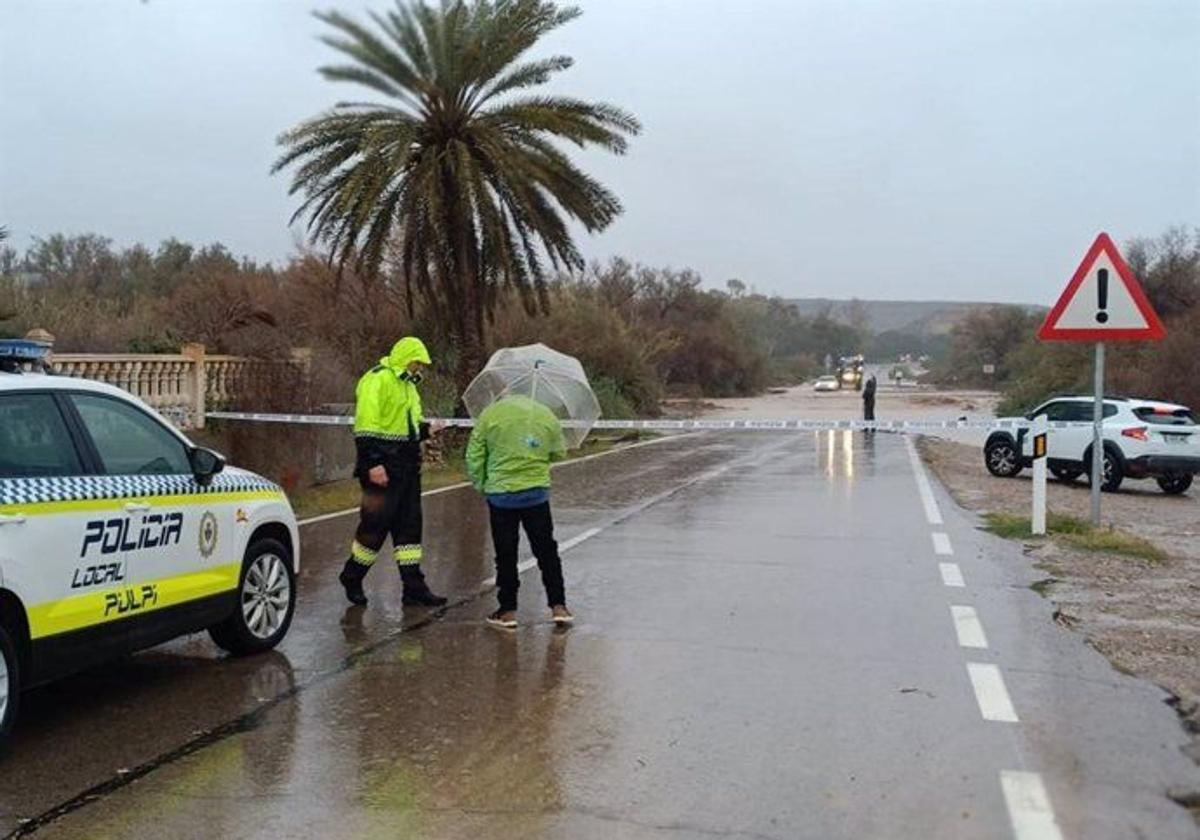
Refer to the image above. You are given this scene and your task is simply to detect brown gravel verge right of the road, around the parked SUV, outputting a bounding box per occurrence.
[920,438,1200,782]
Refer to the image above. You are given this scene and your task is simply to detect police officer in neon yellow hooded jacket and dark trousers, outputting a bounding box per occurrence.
[338,336,446,607]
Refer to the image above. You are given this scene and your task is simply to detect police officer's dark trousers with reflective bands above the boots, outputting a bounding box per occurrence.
[352,464,422,565]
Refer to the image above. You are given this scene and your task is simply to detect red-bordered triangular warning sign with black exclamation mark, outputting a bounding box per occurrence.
[1038,233,1166,341]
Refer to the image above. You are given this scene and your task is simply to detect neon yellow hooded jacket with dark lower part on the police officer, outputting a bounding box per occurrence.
[354,336,430,473]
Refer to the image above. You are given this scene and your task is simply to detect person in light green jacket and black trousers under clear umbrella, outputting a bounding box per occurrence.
[467,395,575,629]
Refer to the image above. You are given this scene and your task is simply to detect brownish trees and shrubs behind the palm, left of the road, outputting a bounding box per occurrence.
[0,234,865,416]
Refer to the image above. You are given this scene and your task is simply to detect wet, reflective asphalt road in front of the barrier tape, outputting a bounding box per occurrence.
[0,432,1200,840]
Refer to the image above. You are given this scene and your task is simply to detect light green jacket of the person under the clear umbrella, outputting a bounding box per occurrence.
[467,395,566,494]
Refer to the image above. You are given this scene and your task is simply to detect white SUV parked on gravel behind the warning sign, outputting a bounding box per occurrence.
[984,396,1200,496]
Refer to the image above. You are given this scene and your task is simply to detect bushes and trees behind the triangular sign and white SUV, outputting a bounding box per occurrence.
[930,228,1200,414]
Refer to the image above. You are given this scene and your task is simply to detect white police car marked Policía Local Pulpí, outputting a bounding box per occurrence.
[0,341,300,739]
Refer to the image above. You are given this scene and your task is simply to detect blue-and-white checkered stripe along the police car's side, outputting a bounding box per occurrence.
[0,474,282,505]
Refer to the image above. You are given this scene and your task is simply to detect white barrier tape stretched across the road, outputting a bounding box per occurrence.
[204,412,1070,432]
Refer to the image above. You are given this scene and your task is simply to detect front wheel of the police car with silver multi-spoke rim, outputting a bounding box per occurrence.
[209,539,296,656]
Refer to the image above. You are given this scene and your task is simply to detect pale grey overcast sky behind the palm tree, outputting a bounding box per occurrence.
[0,0,1200,302]
